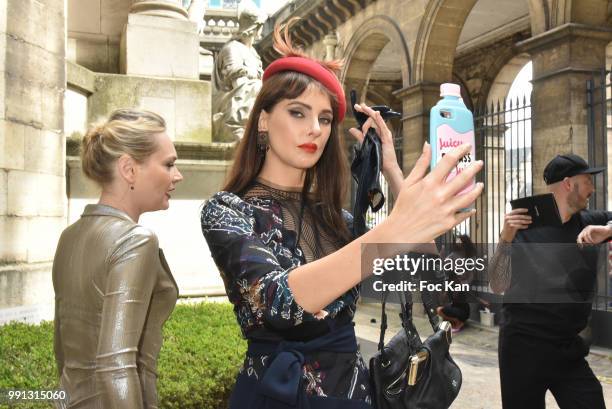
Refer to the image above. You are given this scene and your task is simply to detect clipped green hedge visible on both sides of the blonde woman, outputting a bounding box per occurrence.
[0,303,246,409]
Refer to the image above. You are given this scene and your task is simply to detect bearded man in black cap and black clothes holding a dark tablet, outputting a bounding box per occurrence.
[489,154,612,409]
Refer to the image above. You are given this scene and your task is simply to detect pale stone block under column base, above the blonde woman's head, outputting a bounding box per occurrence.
[119,0,200,79]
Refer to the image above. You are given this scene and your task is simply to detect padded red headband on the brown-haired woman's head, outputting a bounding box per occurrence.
[263,57,346,123]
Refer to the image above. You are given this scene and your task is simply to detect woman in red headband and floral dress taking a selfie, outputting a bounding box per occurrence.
[201,22,482,409]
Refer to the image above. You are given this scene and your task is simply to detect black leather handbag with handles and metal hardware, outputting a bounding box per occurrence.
[370,286,462,409]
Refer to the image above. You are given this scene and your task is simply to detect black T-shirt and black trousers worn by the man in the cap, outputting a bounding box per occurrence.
[498,211,612,409]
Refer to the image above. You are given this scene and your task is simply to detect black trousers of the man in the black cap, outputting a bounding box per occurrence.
[499,329,606,409]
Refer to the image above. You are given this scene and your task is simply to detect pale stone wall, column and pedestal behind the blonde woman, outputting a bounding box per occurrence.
[0,0,231,322]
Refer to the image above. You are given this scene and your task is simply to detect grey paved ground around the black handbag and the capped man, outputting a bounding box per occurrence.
[355,304,612,409]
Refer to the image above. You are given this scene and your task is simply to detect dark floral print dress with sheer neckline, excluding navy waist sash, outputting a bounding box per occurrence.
[201,180,370,403]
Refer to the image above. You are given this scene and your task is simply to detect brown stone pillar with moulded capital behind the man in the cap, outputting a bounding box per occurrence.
[518,23,612,193]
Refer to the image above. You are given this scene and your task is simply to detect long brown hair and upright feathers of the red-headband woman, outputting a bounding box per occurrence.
[223,19,351,243]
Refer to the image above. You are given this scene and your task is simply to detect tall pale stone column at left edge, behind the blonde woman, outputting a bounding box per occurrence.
[0,0,66,322]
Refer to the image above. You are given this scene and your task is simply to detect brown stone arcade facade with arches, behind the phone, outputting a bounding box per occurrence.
[260,0,612,192]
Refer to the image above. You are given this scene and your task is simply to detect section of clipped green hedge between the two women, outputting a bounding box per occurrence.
[157,303,246,409]
